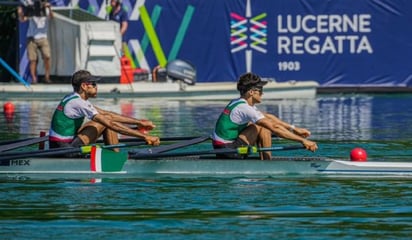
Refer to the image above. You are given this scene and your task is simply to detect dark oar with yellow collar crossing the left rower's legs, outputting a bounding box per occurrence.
[0,143,143,160]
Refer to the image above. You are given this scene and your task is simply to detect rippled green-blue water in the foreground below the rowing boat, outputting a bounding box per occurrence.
[0,177,412,239]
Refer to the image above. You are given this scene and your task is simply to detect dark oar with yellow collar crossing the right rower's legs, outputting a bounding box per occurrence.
[129,145,305,159]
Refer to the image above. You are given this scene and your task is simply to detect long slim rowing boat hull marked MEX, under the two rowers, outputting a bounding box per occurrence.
[0,157,412,178]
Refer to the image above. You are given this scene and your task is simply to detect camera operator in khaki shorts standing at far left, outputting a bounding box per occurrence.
[17,1,53,84]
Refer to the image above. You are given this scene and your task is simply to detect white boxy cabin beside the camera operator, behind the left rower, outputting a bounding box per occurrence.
[38,8,121,79]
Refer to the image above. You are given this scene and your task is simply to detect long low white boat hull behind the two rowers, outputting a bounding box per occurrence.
[0,81,319,100]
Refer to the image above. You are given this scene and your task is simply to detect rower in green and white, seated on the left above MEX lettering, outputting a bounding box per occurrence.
[49,70,160,152]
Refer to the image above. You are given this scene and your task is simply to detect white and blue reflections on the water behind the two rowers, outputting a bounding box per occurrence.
[0,96,412,141]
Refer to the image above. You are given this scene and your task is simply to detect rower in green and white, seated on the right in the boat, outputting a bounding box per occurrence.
[212,73,318,160]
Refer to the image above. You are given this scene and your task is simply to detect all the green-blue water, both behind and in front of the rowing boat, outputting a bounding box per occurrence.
[0,95,412,239]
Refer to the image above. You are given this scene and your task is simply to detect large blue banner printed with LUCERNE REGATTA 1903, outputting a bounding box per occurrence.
[20,0,412,86]
